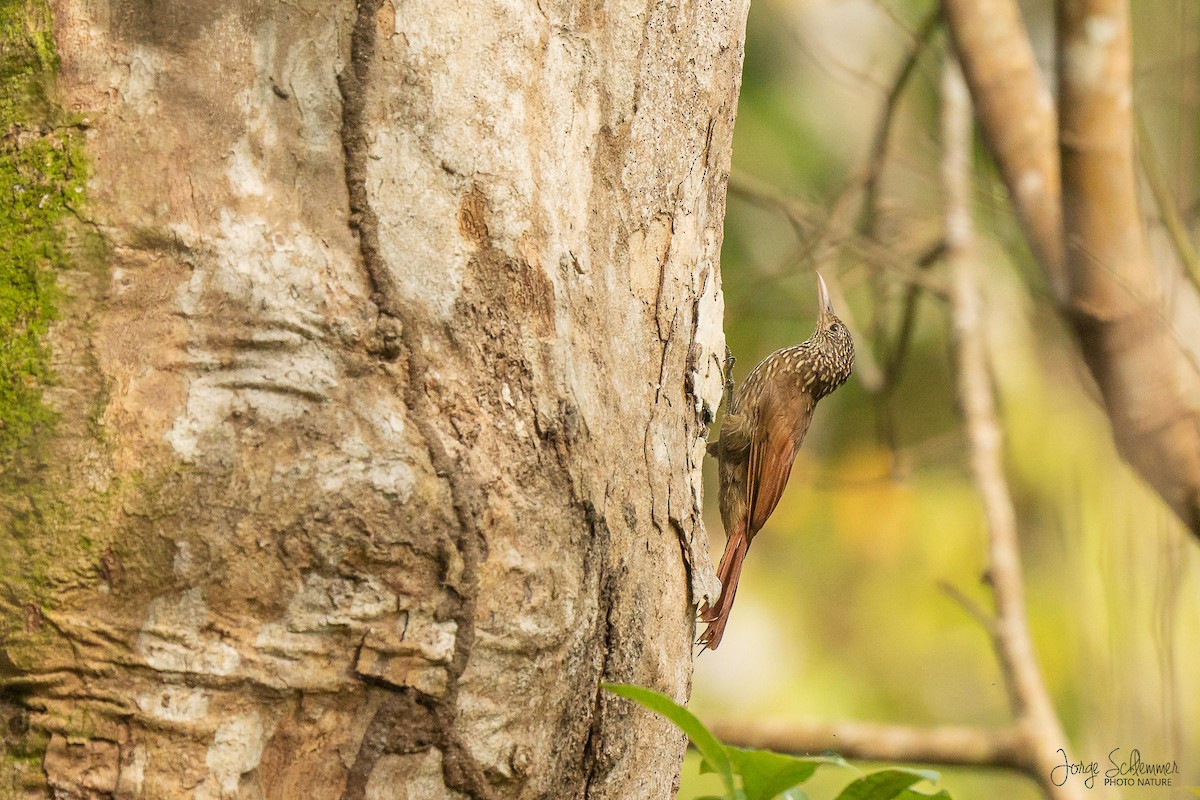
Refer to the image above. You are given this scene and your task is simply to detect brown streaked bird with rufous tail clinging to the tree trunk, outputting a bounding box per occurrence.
[697,272,854,651]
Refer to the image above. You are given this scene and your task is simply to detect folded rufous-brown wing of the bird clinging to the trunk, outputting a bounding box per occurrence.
[746,392,815,536]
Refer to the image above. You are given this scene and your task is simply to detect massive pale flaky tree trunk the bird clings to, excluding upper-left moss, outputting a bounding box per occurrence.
[0,0,746,800]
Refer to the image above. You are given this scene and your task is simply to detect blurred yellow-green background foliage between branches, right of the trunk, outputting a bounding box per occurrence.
[679,0,1200,799]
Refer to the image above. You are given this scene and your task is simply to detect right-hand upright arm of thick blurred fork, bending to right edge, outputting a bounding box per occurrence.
[1058,0,1200,536]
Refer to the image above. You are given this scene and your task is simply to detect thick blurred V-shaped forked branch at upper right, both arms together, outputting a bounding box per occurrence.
[943,0,1200,536]
